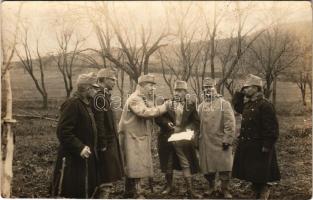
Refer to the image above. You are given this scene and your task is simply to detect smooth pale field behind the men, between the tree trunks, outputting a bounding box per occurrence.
[11,64,309,102]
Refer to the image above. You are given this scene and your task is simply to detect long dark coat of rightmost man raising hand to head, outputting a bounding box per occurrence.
[232,92,280,183]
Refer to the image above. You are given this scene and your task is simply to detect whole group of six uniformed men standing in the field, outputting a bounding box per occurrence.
[51,68,280,199]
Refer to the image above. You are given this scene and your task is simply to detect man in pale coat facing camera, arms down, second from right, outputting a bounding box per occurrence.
[199,78,236,198]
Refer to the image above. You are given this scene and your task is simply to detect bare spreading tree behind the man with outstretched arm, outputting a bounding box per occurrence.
[86,2,168,82]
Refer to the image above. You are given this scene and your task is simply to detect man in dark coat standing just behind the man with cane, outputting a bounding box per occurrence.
[93,68,124,199]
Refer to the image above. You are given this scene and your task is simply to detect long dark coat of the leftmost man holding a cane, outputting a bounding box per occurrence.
[50,94,98,198]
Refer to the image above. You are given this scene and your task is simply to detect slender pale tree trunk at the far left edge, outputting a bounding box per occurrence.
[1,70,16,198]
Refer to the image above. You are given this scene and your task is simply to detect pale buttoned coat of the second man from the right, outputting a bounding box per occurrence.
[198,96,236,174]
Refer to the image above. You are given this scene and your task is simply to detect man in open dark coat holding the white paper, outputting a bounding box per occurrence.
[156,81,200,198]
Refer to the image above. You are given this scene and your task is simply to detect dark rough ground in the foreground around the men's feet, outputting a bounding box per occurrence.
[12,102,312,199]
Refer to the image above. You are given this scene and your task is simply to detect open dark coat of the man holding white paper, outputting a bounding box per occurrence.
[155,102,200,174]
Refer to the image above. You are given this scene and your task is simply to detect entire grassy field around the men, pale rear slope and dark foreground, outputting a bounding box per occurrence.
[8,65,312,199]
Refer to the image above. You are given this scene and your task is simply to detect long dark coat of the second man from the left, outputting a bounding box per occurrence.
[93,87,124,184]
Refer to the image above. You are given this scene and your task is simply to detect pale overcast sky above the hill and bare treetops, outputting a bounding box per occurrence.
[1,1,312,60]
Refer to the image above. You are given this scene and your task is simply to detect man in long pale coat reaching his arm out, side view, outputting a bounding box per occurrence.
[119,74,169,198]
